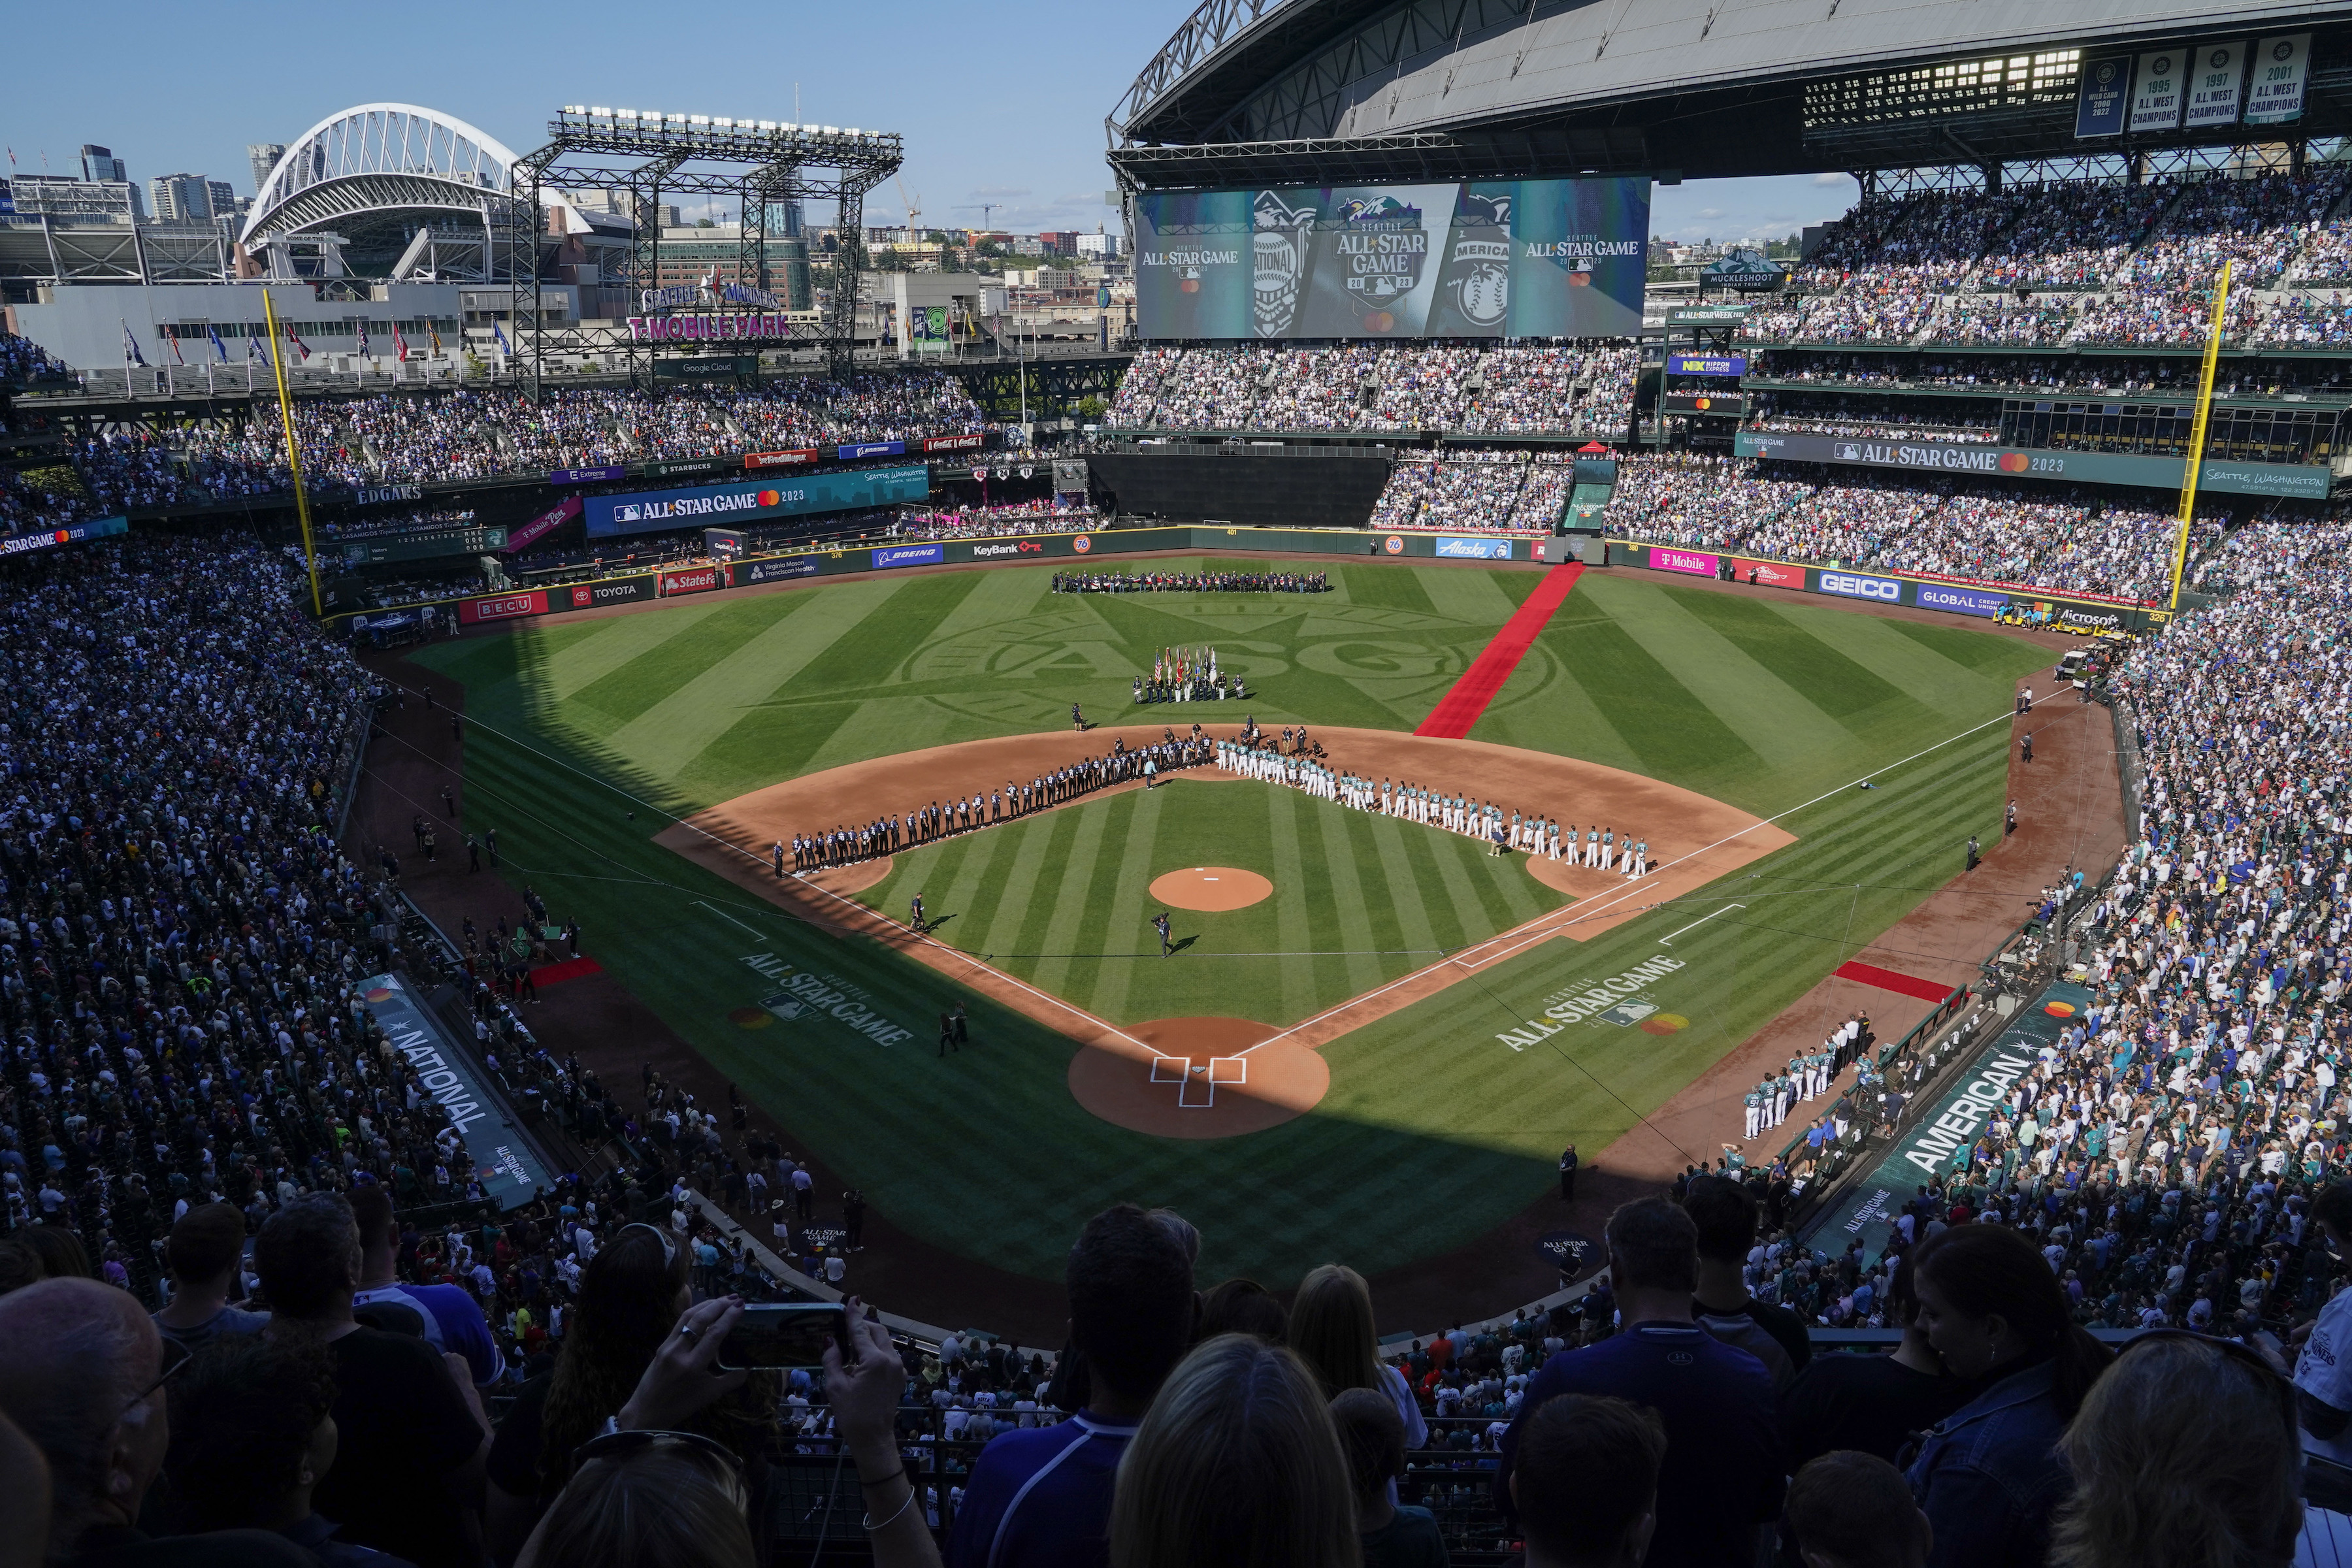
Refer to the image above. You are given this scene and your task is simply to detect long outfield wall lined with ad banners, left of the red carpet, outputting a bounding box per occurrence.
[357,524,1552,625]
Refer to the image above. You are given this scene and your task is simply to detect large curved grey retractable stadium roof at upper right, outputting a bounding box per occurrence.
[1110,0,2352,186]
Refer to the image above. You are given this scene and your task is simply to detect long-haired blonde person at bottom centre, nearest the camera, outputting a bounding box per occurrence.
[1110,1333,1362,1568]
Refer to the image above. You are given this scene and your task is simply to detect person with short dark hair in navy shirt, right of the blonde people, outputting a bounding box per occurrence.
[1496,1199,1785,1568]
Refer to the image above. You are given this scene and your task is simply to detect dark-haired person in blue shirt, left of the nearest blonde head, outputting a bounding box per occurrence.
[948,1203,1194,1568]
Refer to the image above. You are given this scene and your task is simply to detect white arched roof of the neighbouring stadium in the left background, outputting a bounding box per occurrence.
[238,103,534,249]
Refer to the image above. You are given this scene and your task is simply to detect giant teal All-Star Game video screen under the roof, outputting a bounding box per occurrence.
[1136,178,1649,338]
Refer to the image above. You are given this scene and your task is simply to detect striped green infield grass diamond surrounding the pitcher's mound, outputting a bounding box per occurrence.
[861,774,1571,1022]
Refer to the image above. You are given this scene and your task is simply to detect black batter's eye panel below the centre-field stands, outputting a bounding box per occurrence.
[1086,442,1390,529]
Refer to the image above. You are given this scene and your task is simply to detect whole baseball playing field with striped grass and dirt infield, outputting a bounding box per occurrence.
[416,557,2049,1286]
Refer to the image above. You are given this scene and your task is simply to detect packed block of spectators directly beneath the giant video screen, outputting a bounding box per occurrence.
[1103,343,1639,435]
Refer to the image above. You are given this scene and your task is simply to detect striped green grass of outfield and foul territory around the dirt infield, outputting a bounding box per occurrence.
[419,559,2049,1284]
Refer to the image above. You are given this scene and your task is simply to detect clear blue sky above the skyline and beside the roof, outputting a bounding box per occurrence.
[0,0,1854,240]
